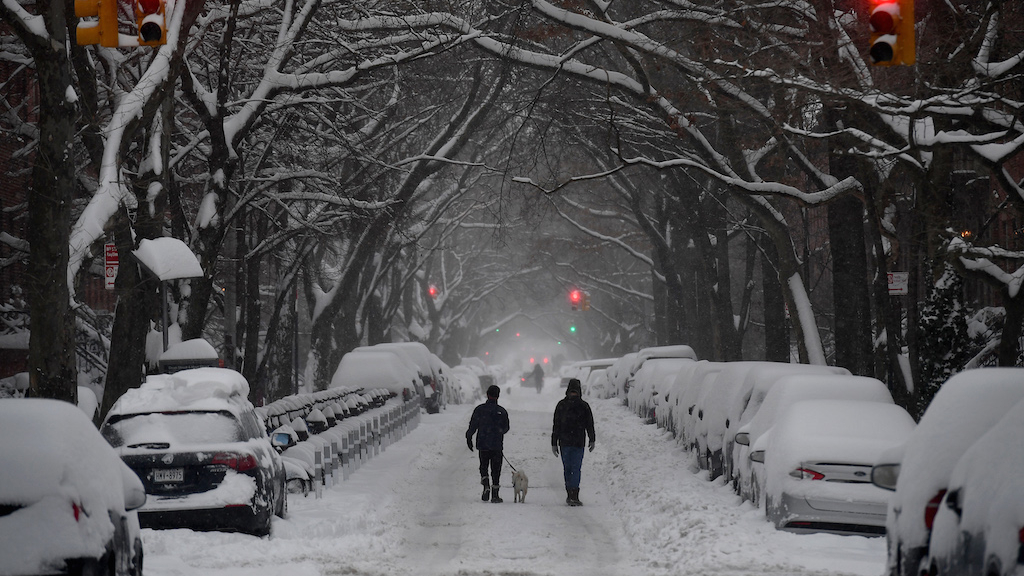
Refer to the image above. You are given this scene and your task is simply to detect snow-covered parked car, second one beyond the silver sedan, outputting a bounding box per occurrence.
[724,362,850,494]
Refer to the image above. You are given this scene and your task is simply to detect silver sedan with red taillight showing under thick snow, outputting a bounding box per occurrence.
[751,400,914,536]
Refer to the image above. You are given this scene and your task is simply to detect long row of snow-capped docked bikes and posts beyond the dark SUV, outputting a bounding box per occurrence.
[257,388,423,498]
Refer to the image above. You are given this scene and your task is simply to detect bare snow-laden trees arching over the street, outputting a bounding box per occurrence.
[0,0,1024,412]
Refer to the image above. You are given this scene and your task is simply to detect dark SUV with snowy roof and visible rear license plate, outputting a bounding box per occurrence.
[100,368,288,535]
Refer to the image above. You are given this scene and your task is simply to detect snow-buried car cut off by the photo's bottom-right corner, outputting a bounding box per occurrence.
[928,391,1024,576]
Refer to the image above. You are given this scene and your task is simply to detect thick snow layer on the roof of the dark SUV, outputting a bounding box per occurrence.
[110,368,250,415]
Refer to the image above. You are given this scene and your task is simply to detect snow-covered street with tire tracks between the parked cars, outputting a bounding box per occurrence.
[143,378,885,576]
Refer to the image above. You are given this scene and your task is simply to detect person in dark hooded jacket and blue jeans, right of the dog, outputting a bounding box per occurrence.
[551,378,595,506]
